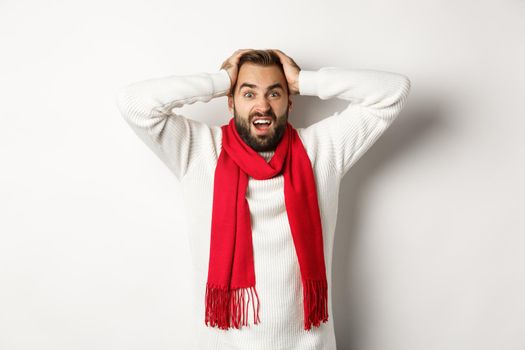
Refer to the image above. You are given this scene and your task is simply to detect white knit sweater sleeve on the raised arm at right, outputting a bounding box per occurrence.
[299,67,411,177]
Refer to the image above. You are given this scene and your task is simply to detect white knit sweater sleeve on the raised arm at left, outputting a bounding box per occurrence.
[116,69,231,181]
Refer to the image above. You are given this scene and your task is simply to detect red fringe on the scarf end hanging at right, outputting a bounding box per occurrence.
[303,280,328,330]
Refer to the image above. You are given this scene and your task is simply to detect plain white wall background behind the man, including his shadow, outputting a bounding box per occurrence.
[0,0,525,350]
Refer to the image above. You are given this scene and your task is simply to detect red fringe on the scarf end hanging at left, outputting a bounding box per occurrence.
[205,284,260,329]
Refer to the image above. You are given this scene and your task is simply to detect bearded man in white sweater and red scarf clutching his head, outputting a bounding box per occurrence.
[118,50,410,350]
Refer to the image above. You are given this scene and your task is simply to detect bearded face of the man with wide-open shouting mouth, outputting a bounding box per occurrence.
[228,63,292,152]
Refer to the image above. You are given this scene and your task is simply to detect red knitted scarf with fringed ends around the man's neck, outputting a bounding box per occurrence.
[205,118,328,330]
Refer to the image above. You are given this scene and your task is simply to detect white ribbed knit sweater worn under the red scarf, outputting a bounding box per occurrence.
[117,67,410,350]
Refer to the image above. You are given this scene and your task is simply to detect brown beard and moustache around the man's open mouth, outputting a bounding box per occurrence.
[233,107,289,152]
